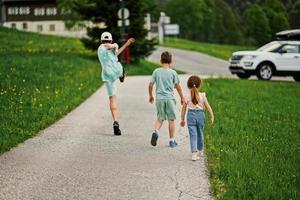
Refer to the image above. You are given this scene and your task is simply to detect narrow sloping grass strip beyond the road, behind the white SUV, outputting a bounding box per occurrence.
[162,37,255,60]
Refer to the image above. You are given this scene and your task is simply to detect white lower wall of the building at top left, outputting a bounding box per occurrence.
[3,20,86,38]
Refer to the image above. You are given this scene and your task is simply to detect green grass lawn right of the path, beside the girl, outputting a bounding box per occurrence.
[202,79,300,200]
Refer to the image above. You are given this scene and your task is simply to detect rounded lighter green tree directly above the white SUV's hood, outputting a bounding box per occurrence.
[244,4,271,45]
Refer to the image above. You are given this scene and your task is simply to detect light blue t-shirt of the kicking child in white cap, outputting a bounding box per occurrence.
[98,44,123,82]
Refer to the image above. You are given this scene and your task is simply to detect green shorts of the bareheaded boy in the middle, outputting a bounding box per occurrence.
[156,99,176,120]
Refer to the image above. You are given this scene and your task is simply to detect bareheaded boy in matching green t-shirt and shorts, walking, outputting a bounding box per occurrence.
[148,51,184,148]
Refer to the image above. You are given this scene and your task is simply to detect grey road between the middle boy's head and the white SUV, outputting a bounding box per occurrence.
[148,47,231,76]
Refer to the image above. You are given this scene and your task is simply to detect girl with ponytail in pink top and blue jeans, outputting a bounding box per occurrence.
[180,76,214,161]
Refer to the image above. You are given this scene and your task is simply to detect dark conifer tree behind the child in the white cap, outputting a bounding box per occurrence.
[59,0,155,61]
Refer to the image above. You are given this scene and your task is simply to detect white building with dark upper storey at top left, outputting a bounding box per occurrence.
[0,0,86,37]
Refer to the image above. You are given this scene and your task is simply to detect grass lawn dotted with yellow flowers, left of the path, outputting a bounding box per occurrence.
[0,28,158,154]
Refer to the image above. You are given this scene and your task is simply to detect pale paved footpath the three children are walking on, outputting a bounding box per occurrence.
[0,76,211,200]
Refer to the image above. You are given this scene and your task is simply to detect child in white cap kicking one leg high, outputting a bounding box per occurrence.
[98,32,135,135]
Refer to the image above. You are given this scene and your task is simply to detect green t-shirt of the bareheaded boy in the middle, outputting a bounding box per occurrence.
[150,67,179,99]
